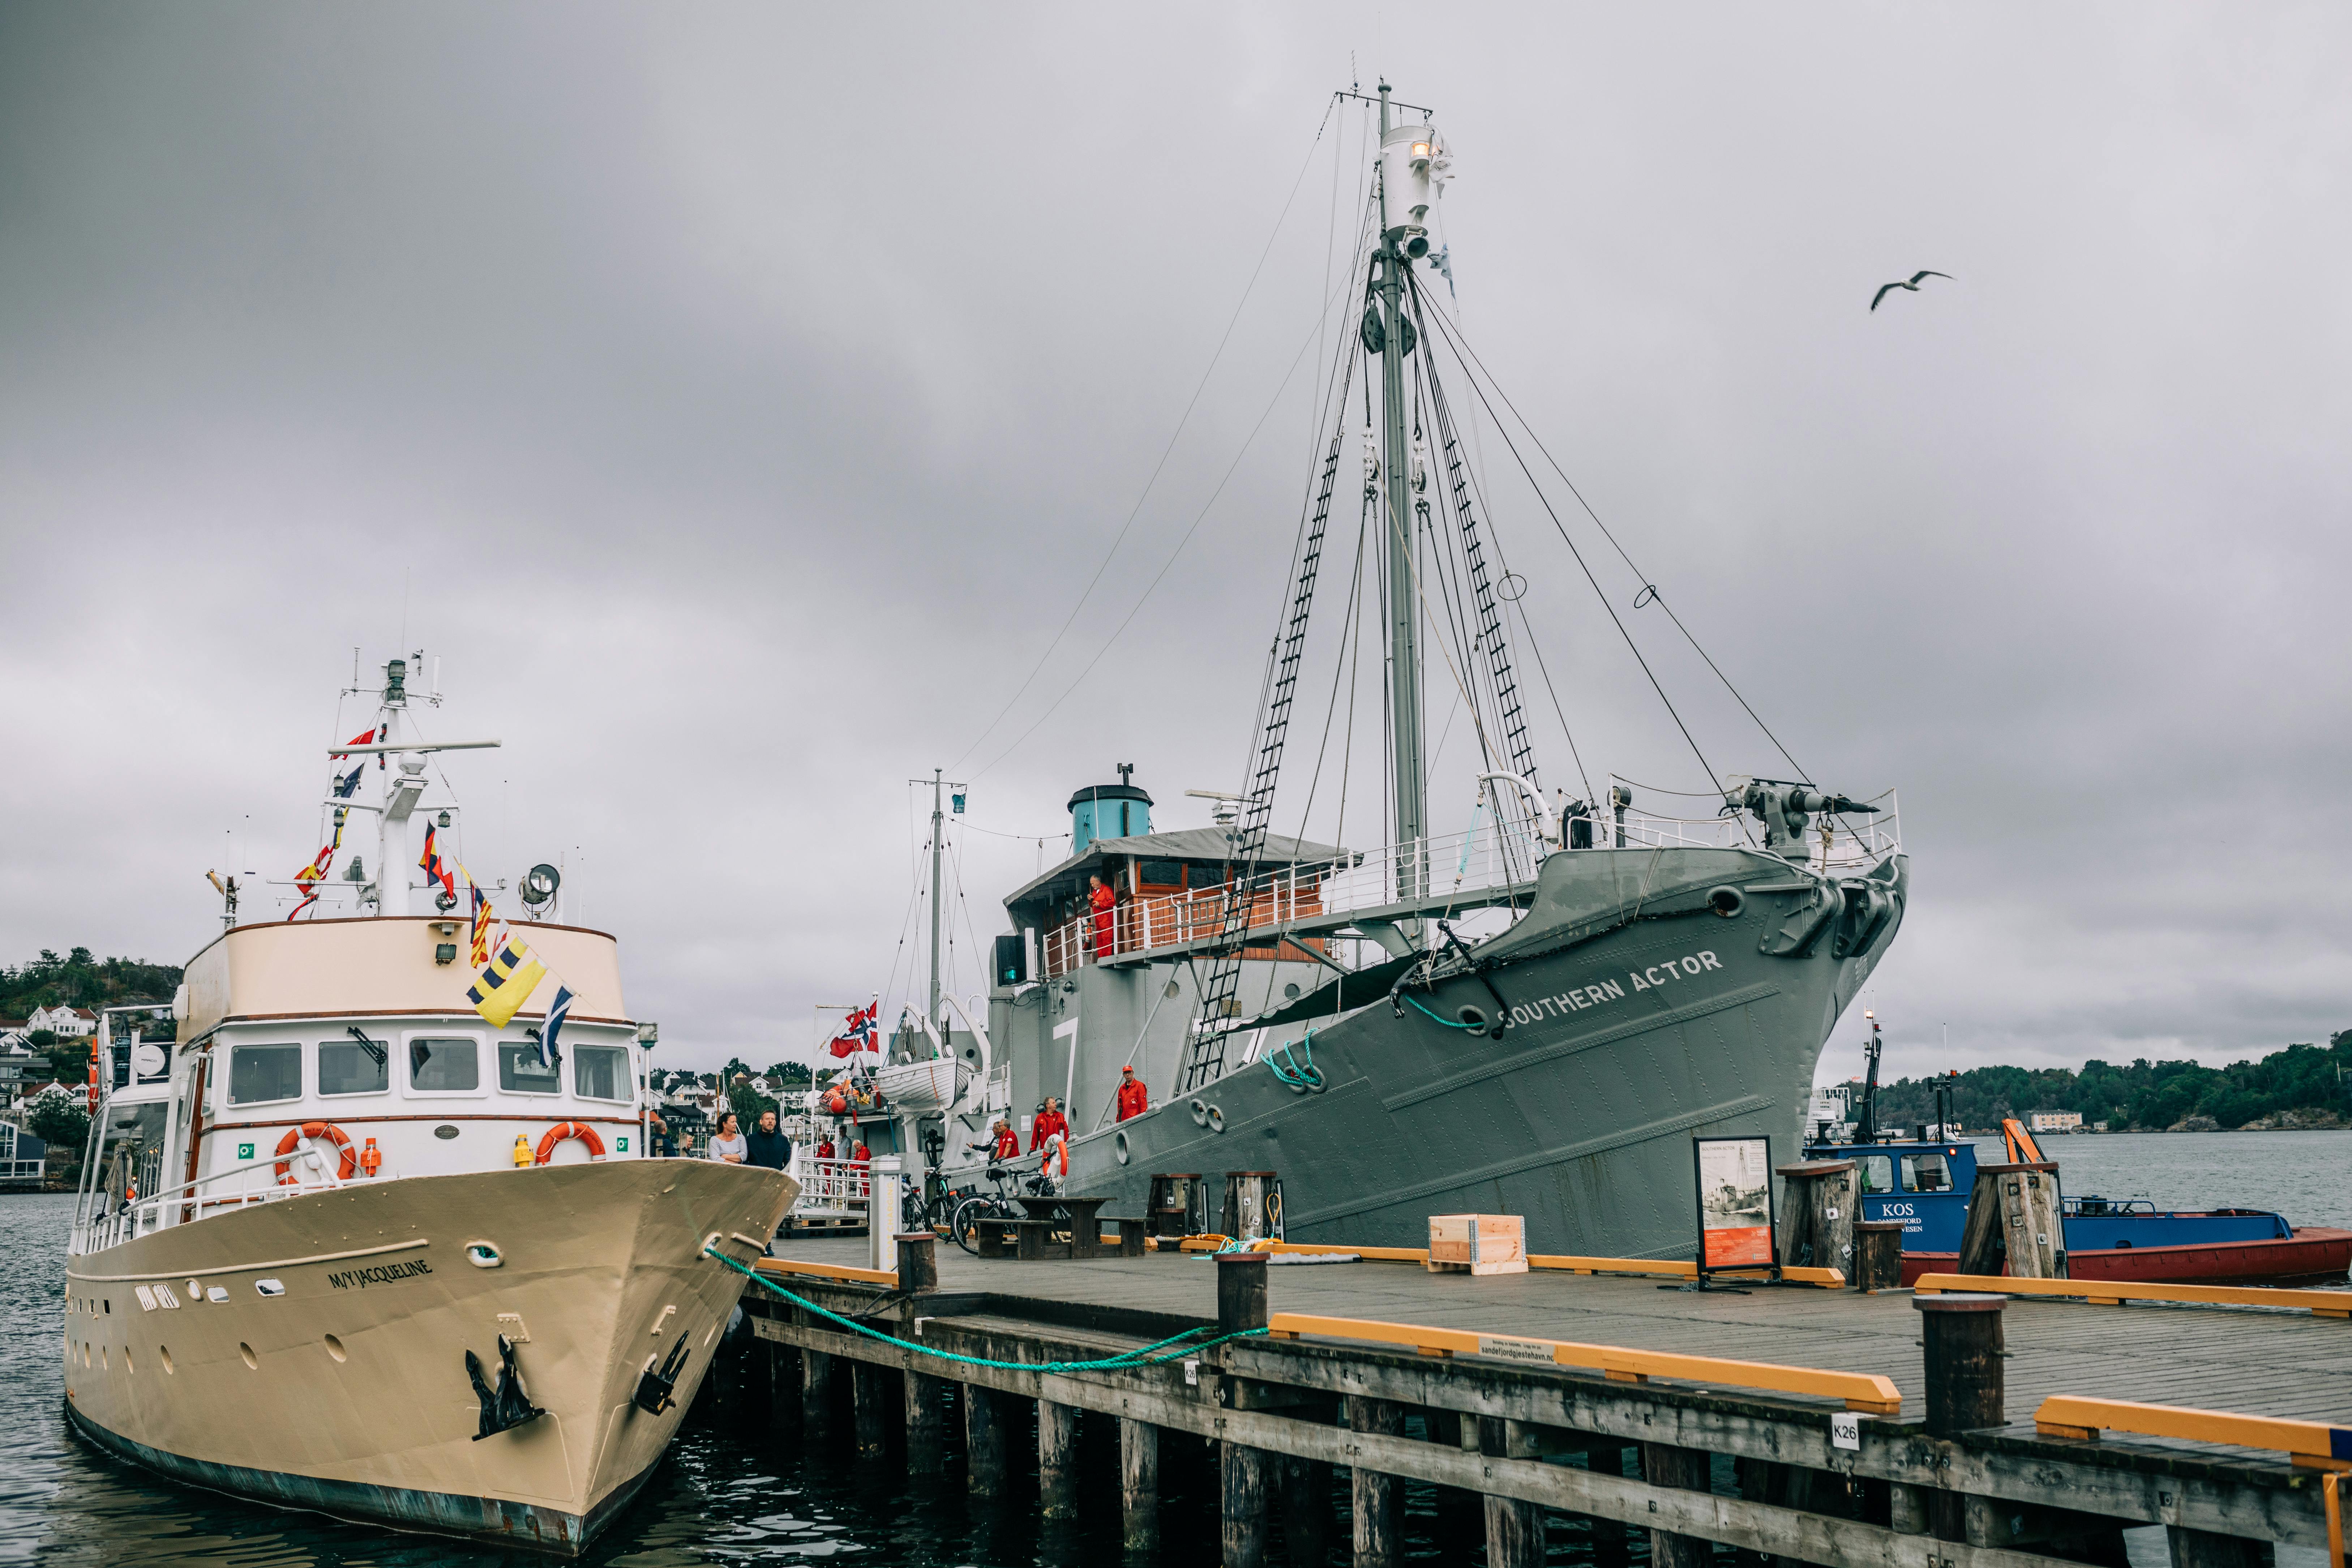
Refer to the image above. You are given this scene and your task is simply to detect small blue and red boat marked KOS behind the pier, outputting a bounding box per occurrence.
[1806,1013,2352,1286]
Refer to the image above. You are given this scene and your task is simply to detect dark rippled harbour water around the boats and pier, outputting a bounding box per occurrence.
[0,1133,2352,1568]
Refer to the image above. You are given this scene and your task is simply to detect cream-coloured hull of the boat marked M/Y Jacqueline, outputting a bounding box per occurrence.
[66,1159,797,1551]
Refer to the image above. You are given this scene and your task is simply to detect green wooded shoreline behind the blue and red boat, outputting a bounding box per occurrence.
[1879,1030,2352,1128]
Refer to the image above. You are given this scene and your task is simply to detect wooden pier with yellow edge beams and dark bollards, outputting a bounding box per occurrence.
[729,1239,2352,1568]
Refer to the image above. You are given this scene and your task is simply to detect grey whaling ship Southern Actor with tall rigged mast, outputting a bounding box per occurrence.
[877,85,1907,1258]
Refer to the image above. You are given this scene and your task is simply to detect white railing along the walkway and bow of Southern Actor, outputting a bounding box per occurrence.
[1037,790,1903,980]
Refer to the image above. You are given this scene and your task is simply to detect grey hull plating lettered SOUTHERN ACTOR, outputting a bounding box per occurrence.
[1070,849,1907,1258]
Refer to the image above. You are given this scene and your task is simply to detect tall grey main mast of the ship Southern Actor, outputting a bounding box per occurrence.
[1378,80,1428,900]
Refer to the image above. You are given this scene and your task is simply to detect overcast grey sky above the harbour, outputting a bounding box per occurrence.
[0,5,2352,1077]
